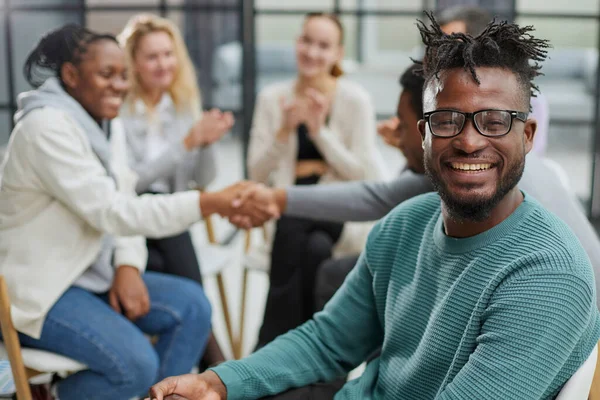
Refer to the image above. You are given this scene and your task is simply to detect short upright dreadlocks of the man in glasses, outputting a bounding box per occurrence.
[415,12,551,103]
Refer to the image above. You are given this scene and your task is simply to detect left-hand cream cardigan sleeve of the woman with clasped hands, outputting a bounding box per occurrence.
[248,88,289,184]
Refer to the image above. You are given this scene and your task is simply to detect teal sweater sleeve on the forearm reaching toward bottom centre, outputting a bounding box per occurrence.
[209,255,383,400]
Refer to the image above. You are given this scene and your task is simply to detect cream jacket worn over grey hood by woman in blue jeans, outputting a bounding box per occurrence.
[0,107,201,338]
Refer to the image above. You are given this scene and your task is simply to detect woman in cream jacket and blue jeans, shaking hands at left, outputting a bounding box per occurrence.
[0,25,253,400]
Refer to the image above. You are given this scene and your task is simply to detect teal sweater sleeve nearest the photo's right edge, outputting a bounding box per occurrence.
[436,272,598,400]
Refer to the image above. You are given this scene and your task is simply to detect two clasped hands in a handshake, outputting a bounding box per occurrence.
[200,181,287,229]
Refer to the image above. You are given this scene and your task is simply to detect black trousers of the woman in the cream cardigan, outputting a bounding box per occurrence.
[258,216,344,348]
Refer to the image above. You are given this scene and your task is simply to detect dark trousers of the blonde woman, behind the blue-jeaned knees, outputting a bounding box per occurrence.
[146,231,202,285]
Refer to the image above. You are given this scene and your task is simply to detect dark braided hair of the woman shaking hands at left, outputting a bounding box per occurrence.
[23,24,117,87]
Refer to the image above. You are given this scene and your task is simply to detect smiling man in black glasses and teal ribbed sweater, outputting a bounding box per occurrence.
[150,14,600,400]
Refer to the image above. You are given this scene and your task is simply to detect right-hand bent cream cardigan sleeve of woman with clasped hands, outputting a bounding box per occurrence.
[313,92,377,180]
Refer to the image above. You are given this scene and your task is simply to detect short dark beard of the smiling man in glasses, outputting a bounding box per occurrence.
[425,150,525,222]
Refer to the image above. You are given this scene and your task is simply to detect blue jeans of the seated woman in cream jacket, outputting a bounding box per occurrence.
[20,272,211,400]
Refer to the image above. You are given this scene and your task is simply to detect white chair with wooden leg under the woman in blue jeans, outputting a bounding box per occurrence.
[0,276,87,400]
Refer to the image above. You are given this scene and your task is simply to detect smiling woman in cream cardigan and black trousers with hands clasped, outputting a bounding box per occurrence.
[248,13,381,347]
